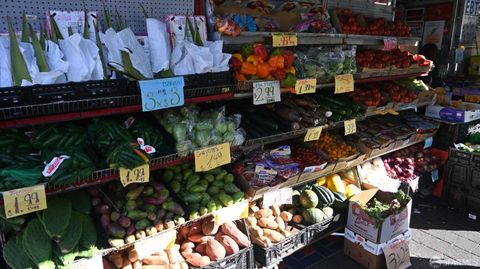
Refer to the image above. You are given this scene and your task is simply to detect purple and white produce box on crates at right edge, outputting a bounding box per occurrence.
[425,102,480,122]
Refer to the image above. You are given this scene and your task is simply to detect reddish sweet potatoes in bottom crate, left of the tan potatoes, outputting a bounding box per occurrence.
[177,217,251,267]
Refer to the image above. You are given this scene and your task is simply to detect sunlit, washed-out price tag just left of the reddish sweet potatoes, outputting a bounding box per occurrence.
[135,230,177,260]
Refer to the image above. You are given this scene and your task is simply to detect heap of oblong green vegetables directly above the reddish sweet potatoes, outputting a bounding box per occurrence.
[162,164,244,220]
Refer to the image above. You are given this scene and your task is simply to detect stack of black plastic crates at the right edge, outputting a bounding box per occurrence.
[446,148,480,213]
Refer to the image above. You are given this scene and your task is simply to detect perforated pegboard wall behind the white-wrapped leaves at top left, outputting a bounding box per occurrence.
[0,0,194,33]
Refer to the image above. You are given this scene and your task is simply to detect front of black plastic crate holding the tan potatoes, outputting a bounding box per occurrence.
[253,226,306,267]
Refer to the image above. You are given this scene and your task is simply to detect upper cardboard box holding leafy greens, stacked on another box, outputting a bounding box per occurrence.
[347,188,412,244]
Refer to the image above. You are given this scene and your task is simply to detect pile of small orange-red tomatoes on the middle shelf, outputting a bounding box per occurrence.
[313,132,357,161]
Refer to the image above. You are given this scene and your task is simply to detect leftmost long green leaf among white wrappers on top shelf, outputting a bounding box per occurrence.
[7,16,32,86]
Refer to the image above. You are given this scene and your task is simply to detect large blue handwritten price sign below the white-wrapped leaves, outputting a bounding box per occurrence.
[138,77,185,112]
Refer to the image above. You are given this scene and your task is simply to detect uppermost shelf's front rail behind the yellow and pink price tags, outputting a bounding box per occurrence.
[221,32,420,46]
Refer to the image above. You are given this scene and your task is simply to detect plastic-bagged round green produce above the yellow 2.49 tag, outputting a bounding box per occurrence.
[153,105,245,155]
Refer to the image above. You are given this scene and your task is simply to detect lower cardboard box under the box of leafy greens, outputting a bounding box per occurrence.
[343,228,412,269]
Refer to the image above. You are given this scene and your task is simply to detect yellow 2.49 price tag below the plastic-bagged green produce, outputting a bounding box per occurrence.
[194,143,232,172]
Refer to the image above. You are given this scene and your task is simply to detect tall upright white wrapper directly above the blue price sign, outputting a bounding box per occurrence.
[147,18,171,73]
